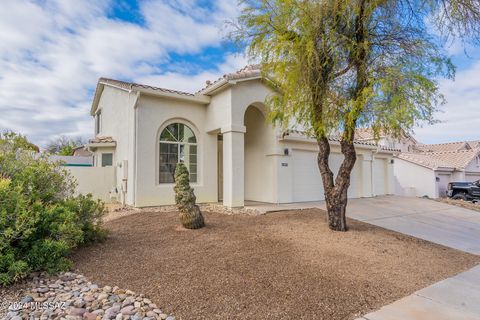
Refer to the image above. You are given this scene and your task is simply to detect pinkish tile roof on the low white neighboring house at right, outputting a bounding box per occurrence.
[397,149,480,169]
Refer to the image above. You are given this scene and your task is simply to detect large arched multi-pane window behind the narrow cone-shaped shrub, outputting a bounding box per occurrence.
[159,123,197,183]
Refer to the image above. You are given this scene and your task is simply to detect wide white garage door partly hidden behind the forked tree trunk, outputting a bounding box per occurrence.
[292,150,361,202]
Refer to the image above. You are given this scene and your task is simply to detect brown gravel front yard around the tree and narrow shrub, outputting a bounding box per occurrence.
[74,209,480,320]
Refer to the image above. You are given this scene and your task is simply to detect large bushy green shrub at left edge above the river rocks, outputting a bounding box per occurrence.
[0,132,106,285]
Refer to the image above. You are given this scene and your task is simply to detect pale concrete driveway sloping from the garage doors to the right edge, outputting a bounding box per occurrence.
[347,196,480,255]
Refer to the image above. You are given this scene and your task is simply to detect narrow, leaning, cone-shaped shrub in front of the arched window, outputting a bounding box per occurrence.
[174,163,205,229]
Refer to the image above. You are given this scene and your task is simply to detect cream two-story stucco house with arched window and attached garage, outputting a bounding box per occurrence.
[88,66,394,207]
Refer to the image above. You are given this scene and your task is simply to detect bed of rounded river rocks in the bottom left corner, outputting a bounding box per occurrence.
[0,272,175,320]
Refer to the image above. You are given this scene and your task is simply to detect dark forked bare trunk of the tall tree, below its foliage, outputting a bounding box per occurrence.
[317,134,357,231]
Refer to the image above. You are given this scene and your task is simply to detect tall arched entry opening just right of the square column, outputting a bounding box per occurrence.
[244,103,275,202]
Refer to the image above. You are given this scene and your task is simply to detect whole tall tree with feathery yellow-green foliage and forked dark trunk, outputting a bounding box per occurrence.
[231,0,480,231]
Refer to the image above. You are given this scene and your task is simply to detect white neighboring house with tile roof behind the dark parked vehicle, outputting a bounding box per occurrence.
[394,141,480,198]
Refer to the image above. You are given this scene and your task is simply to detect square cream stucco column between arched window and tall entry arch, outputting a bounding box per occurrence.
[222,125,246,208]
